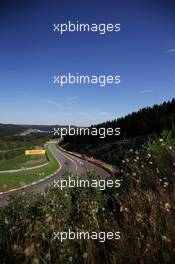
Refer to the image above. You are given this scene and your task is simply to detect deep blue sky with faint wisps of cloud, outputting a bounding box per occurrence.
[0,0,175,125]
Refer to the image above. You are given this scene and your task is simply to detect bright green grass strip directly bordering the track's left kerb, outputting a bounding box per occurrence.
[0,146,59,191]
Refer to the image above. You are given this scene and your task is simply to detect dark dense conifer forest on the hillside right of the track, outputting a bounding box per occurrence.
[61,99,175,165]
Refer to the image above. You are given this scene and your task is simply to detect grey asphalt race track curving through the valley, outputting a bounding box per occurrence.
[0,144,110,206]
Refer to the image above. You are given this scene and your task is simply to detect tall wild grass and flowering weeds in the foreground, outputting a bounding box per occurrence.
[0,131,175,264]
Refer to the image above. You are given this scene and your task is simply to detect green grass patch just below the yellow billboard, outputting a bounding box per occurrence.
[0,154,48,171]
